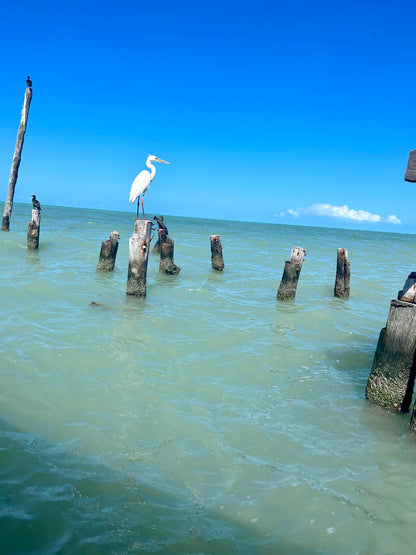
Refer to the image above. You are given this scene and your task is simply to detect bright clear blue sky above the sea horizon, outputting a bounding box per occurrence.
[0,0,416,233]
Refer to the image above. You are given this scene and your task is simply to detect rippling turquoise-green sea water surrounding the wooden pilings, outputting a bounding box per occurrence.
[0,204,416,554]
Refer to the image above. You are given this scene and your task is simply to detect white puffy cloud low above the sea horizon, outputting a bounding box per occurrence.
[280,203,401,224]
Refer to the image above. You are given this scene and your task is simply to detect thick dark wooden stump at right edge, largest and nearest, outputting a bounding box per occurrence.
[365,300,416,412]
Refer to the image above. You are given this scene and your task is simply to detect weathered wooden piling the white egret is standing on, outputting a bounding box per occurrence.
[126,219,153,297]
